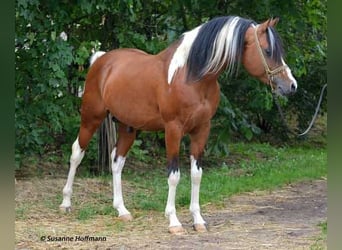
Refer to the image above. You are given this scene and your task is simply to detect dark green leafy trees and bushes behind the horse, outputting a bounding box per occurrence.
[15,0,327,170]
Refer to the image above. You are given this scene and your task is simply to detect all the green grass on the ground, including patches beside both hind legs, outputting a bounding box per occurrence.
[16,143,327,221]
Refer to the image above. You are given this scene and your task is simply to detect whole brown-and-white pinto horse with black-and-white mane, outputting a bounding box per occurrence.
[60,16,297,234]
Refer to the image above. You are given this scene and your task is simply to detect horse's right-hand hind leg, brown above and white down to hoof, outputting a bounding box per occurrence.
[111,124,136,221]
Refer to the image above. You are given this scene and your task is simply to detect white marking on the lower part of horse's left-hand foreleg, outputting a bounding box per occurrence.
[165,169,182,227]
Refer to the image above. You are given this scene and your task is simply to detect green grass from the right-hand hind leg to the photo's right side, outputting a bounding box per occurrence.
[117,143,327,211]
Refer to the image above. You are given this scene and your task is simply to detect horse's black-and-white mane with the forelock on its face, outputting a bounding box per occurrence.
[168,16,283,83]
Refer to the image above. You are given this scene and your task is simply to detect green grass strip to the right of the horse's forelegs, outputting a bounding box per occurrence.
[208,145,327,200]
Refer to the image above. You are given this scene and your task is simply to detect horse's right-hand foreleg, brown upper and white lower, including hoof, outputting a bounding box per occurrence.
[190,122,210,232]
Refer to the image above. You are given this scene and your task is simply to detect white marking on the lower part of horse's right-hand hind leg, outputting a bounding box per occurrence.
[111,148,131,216]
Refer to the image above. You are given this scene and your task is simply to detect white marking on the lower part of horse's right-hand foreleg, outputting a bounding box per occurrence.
[190,155,206,225]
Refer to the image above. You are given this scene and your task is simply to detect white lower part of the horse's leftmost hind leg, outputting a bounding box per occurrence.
[59,137,84,211]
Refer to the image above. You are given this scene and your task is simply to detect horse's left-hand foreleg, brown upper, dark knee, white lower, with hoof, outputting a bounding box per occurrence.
[165,124,185,234]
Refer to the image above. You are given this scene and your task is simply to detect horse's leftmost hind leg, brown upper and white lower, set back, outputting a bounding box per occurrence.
[59,105,106,212]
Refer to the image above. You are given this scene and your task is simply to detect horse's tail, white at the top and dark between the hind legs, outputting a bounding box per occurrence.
[90,51,116,173]
